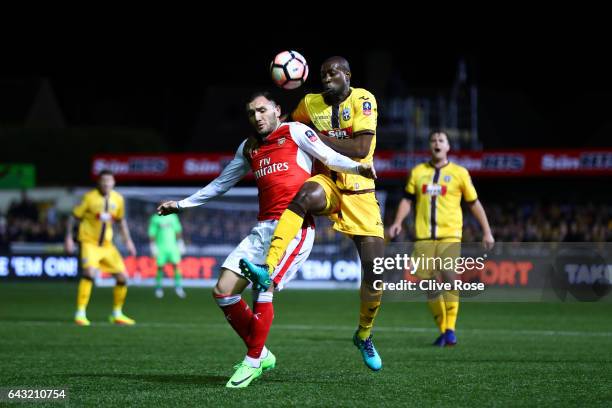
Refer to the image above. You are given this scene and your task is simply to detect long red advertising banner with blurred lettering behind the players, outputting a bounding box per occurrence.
[91,148,612,181]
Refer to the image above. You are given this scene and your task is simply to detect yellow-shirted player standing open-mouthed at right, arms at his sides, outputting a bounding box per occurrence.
[389,131,495,347]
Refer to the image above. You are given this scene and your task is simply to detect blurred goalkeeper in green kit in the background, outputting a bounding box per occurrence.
[149,214,186,298]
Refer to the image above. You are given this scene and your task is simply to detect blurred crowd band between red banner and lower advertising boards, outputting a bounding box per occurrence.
[0,190,612,248]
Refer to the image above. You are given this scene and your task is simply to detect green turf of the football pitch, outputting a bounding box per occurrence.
[0,283,612,407]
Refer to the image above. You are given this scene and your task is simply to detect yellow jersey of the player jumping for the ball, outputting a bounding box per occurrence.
[291,88,378,191]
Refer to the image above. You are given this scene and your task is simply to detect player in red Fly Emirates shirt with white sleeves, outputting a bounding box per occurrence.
[157,92,376,388]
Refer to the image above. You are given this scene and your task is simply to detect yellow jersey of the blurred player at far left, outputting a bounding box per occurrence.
[72,188,125,246]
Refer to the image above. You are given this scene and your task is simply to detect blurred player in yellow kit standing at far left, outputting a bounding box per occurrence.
[65,171,136,326]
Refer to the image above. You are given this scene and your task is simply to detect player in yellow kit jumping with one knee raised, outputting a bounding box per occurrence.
[244,57,384,371]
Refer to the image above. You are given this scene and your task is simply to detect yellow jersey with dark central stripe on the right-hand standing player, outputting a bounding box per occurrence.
[406,162,478,240]
